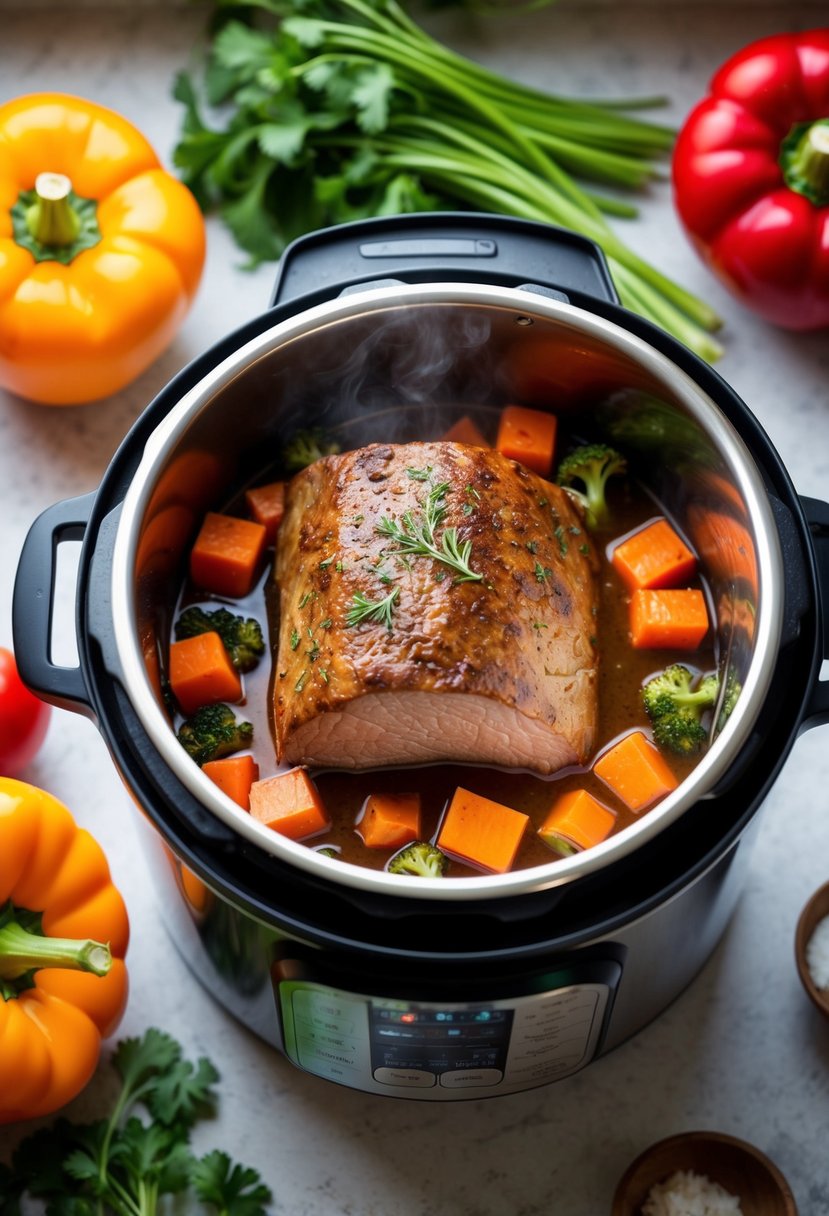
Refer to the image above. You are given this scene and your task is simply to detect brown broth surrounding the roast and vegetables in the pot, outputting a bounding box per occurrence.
[166,457,716,877]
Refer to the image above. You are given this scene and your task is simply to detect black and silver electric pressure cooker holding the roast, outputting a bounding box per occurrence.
[13,214,829,1100]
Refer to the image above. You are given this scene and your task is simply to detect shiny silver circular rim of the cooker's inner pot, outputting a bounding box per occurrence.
[111,282,784,901]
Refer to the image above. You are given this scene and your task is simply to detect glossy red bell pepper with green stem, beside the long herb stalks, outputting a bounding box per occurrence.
[673,28,829,330]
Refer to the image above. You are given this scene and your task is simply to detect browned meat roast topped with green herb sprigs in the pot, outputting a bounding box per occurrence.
[273,443,597,773]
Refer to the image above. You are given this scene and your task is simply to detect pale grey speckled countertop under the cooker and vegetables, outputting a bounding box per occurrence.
[0,0,829,1216]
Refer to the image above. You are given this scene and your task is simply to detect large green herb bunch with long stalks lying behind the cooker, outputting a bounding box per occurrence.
[174,0,720,359]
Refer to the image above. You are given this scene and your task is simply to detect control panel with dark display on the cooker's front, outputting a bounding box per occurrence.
[275,962,621,1100]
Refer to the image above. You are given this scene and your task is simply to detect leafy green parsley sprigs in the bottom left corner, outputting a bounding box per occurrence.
[0,1029,272,1216]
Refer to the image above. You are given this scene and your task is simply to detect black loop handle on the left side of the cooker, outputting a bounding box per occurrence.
[12,492,95,717]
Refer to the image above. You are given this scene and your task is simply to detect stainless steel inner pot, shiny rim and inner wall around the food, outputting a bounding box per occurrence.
[111,282,784,901]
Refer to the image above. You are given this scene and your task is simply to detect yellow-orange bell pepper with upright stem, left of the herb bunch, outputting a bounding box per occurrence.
[0,94,205,405]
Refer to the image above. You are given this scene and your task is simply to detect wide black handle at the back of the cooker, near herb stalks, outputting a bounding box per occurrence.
[271,212,619,308]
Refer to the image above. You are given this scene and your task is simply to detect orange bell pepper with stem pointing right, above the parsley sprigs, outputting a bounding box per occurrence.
[0,777,129,1124]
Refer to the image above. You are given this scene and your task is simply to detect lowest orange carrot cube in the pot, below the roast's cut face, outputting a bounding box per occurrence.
[438,787,530,874]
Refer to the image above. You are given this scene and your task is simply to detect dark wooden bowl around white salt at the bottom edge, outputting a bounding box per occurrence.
[611,1132,797,1216]
